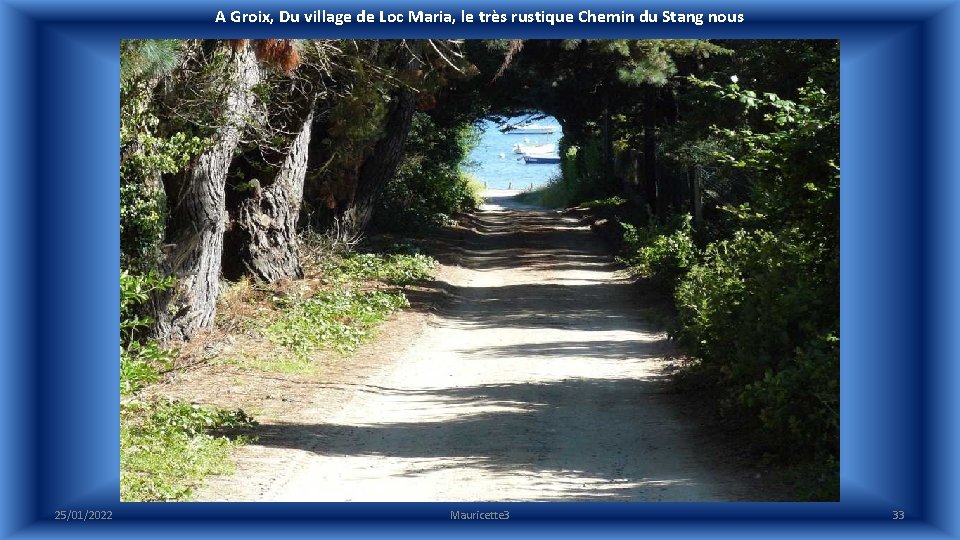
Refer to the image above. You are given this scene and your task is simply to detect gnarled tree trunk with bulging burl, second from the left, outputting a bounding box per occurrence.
[237,105,314,283]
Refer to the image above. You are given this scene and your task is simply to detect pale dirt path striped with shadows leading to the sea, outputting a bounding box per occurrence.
[199,190,755,501]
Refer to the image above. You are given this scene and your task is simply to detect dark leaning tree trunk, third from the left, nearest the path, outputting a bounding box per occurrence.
[337,90,416,242]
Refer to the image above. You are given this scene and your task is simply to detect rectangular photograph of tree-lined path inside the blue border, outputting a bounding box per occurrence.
[119,39,840,502]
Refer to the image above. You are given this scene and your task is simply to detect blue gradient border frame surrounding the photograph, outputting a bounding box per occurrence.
[0,0,960,538]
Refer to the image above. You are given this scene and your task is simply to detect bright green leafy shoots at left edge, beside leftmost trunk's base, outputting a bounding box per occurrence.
[120,270,176,395]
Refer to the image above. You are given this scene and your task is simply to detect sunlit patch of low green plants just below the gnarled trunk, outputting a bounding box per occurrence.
[267,289,410,355]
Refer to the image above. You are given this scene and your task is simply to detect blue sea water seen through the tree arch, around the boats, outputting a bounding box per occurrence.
[464,116,563,189]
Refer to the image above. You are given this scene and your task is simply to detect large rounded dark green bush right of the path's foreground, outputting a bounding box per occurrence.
[675,230,839,456]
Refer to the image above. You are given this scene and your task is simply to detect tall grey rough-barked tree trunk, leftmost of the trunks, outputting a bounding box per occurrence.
[156,44,260,342]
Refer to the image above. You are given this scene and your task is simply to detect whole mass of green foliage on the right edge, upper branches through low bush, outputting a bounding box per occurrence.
[676,76,840,463]
